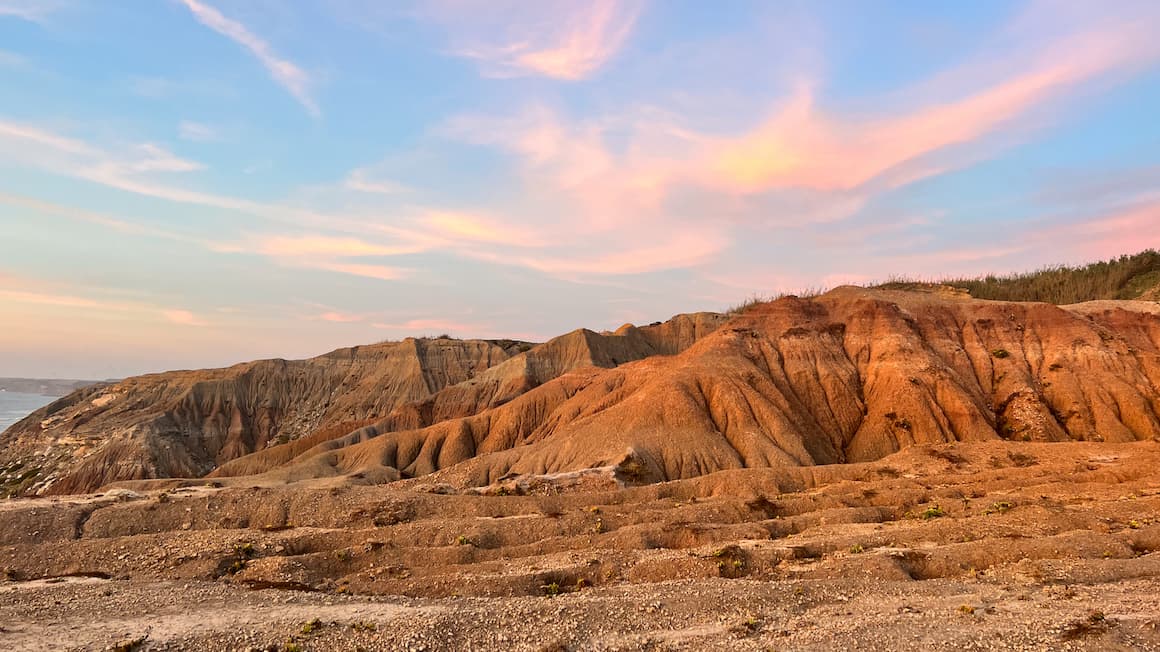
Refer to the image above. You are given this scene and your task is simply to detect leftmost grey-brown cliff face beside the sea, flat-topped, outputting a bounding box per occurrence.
[0,339,530,493]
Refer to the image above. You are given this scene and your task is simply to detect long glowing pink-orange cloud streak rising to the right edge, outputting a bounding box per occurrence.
[704,29,1160,193]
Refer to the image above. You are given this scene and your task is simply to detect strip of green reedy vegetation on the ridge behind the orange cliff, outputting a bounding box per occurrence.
[879,249,1160,305]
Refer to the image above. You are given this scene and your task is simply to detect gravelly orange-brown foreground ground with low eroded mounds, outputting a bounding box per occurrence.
[0,442,1160,651]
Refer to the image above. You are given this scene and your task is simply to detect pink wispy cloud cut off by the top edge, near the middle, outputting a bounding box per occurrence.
[421,0,643,80]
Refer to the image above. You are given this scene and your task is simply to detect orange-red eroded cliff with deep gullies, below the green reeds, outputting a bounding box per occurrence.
[223,288,1160,486]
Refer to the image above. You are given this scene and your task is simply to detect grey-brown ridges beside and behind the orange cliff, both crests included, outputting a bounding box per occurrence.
[0,313,724,494]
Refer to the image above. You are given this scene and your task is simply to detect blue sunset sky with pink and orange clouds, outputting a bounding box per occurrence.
[0,0,1160,378]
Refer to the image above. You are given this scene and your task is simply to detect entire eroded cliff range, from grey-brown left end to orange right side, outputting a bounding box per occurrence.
[3,288,1160,492]
